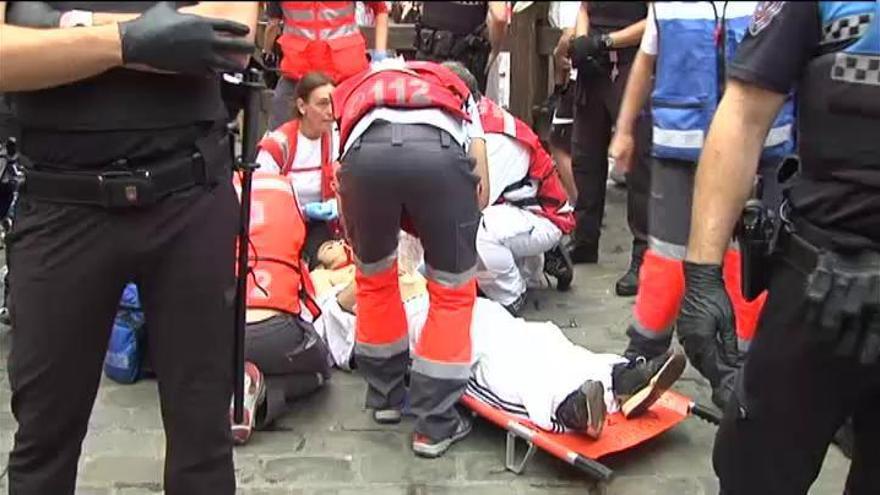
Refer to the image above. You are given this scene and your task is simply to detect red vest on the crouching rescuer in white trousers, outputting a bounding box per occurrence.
[479,98,575,234]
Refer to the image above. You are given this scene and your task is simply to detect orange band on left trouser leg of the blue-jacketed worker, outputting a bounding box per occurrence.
[633,248,684,337]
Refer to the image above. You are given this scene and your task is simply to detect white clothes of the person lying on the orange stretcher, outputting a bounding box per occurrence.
[315,294,626,431]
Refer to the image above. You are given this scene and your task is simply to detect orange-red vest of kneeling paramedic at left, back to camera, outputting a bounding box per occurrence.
[234,172,321,318]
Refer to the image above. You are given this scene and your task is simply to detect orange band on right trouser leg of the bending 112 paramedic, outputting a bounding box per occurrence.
[415,279,477,366]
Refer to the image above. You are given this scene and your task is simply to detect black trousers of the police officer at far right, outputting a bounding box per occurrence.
[714,238,880,495]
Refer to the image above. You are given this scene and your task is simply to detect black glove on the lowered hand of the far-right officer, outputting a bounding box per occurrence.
[677,261,742,388]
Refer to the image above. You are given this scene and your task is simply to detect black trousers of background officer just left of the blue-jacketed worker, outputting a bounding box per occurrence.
[571,63,651,254]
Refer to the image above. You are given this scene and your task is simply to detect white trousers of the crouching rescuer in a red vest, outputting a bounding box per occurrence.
[477,204,562,306]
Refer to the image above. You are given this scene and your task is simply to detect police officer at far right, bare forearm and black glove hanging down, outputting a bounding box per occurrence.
[679,0,880,495]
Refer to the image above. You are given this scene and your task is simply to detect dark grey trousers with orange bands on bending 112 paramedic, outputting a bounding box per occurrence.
[339,123,480,440]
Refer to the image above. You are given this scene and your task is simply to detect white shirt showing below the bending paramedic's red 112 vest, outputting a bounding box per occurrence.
[342,93,485,156]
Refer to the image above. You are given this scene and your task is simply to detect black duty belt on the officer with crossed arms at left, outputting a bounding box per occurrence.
[20,141,231,208]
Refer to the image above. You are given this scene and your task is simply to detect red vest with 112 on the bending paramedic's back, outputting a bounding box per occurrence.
[333,62,470,156]
